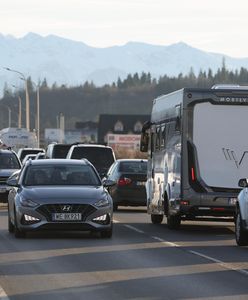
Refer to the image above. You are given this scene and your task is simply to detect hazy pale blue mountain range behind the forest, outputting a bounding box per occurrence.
[0,33,248,91]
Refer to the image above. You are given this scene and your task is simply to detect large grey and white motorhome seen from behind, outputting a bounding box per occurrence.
[140,85,248,229]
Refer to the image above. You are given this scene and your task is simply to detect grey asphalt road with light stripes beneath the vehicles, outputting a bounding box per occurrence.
[0,208,248,300]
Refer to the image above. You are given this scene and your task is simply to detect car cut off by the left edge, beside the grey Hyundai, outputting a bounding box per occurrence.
[0,149,21,202]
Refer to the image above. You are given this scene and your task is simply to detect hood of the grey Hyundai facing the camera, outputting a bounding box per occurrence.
[21,186,108,204]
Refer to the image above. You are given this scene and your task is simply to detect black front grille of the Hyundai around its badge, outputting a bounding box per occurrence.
[36,204,97,221]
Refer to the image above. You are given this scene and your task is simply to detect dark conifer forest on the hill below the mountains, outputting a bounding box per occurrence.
[0,60,248,131]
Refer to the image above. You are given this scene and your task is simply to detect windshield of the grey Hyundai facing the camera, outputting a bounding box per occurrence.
[23,165,101,186]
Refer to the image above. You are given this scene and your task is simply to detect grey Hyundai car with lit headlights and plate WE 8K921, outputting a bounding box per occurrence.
[7,159,114,238]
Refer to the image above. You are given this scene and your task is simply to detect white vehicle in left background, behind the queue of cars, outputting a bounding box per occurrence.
[0,128,38,152]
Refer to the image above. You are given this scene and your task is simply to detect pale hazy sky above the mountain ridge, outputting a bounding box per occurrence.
[0,0,248,57]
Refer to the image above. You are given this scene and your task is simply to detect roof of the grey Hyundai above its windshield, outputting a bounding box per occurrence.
[26,158,91,166]
